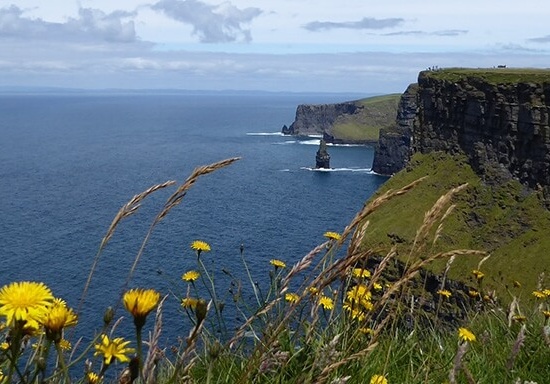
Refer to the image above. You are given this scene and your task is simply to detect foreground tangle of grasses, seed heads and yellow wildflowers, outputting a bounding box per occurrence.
[0,159,550,384]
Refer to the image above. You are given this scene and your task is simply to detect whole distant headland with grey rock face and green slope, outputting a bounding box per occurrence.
[282,94,399,144]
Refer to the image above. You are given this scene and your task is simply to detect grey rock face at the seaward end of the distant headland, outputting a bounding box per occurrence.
[282,102,361,136]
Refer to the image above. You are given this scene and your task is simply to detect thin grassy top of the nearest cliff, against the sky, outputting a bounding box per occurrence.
[420,68,550,85]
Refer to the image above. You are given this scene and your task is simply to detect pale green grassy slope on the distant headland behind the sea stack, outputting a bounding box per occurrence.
[332,94,401,141]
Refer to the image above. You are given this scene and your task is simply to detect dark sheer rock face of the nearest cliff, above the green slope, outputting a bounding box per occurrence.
[373,72,550,187]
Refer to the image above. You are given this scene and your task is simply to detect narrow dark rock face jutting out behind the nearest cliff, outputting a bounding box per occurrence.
[372,84,418,175]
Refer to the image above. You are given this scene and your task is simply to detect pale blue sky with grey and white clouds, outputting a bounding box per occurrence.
[0,0,550,94]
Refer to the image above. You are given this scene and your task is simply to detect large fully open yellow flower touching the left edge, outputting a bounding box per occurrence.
[0,281,53,328]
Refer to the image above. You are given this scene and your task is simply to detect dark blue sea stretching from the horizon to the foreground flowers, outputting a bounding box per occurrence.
[0,93,385,348]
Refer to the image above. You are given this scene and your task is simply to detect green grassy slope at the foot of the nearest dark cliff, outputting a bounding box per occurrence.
[365,153,550,301]
